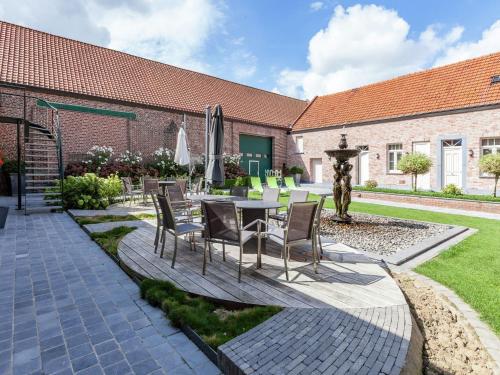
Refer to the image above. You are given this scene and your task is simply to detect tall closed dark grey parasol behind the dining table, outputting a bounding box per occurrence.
[205,104,224,186]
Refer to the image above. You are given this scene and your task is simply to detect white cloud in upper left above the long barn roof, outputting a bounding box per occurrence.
[0,0,228,71]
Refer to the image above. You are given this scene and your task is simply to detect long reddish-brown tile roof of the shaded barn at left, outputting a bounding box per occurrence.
[0,21,307,127]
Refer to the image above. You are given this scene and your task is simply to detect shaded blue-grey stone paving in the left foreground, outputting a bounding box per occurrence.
[0,214,219,375]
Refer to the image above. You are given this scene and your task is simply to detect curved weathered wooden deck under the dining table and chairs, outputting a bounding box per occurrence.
[118,225,406,309]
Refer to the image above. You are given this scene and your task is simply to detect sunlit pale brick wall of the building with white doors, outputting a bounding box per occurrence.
[288,109,500,192]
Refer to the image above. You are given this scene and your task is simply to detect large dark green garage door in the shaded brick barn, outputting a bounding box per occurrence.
[240,134,273,181]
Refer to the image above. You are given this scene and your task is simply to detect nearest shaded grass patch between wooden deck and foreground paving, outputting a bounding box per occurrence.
[141,279,282,349]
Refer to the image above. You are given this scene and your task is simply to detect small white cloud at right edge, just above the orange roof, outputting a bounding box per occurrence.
[434,20,500,66]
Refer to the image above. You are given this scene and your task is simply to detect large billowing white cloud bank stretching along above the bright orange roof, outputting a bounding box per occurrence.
[275,4,500,98]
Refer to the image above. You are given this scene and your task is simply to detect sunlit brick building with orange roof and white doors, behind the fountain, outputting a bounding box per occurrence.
[288,53,500,193]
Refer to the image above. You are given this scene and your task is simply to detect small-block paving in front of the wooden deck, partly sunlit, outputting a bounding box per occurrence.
[218,305,411,375]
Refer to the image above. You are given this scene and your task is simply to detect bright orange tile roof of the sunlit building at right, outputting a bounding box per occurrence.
[293,53,500,130]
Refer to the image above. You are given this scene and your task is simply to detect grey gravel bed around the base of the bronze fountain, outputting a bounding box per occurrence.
[321,212,451,256]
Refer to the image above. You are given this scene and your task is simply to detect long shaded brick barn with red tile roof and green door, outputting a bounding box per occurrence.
[0,22,307,178]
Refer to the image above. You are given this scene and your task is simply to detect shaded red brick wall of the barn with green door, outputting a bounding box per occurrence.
[0,86,287,168]
